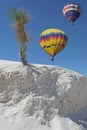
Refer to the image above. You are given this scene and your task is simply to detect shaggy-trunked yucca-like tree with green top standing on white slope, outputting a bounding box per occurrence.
[9,7,31,65]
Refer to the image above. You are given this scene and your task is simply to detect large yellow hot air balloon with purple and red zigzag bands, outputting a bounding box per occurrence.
[40,28,68,60]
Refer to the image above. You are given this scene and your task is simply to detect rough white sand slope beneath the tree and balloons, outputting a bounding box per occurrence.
[0,60,87,130]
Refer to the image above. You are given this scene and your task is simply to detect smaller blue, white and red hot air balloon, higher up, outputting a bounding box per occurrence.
[63,3,82,25]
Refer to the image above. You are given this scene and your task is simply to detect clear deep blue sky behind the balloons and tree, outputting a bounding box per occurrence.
[0,0,87,77]
